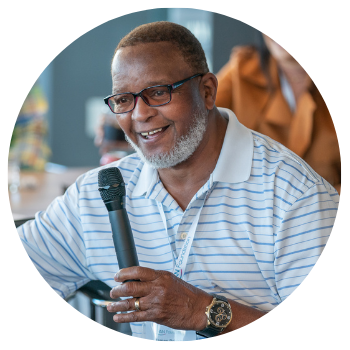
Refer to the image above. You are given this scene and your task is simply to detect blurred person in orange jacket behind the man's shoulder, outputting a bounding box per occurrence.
[216,32,341,194]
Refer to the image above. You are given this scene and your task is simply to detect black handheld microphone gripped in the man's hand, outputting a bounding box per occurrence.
[98,167,139,282]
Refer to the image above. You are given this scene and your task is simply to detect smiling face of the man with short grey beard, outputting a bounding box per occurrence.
[112,42,207,168]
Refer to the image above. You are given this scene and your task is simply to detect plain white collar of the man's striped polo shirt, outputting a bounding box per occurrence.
[133,108,253,197]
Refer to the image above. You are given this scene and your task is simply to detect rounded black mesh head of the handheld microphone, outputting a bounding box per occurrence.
[98,167,125,202]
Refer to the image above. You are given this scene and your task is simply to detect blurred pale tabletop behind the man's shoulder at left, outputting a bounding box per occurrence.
[8,167,91,220]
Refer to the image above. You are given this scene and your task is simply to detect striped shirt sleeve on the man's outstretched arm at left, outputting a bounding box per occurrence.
[17,175,95,298]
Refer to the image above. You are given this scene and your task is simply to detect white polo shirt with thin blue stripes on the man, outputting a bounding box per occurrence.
[17,108,340,336]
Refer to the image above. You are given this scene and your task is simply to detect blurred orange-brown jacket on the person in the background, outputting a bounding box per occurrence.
[216,46,341,194]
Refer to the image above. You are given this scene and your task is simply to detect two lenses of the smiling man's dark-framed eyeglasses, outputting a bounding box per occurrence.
[108,86,170,113]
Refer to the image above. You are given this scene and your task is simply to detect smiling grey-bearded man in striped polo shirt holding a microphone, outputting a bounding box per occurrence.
[18,22,339,341]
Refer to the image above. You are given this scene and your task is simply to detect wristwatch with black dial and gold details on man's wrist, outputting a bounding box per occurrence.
[197,294,232,338]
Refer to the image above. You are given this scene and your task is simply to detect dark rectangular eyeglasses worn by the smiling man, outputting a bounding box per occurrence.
[103,74,204,114]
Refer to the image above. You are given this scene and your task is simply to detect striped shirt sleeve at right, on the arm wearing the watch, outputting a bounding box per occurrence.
[275,182,340,301]
